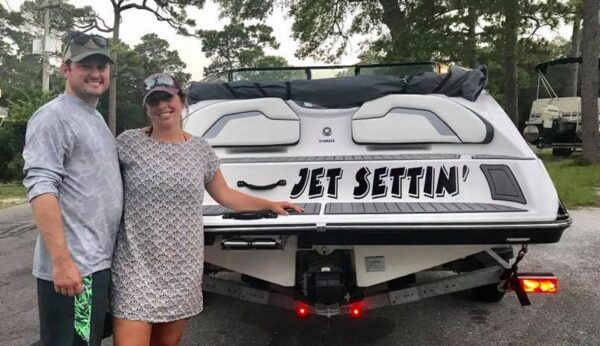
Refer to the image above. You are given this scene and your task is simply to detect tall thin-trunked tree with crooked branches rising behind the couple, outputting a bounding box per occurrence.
[83,0,205,134]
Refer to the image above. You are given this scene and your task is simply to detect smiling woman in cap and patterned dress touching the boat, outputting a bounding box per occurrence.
[111,74,302,346]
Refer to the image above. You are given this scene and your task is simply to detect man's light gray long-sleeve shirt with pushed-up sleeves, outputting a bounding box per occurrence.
[23,94,123,280]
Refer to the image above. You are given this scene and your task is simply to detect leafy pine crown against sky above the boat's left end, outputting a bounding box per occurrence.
[198,22,287,75]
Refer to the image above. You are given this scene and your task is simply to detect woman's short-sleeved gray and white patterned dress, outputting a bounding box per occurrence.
[111,129,219,323]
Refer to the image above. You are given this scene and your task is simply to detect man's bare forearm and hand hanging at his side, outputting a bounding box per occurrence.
[31,193,83,297]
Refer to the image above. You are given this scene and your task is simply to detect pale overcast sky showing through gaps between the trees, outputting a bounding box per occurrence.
[0,0,358,80]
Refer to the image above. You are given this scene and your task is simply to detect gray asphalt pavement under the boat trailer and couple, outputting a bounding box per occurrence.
[0,205,600,346]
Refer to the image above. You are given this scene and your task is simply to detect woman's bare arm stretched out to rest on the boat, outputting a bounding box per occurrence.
[206,169,304,215]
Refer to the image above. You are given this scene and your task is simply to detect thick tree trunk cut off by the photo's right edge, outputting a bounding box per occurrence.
[581,0,600,164]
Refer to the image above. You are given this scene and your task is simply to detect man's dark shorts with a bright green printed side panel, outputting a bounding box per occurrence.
[37,269,110,346]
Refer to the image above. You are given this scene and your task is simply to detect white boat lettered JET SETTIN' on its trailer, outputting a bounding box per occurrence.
[184,63,571,317]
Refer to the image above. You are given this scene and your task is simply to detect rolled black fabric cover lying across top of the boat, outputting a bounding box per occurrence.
[187,66,487,108]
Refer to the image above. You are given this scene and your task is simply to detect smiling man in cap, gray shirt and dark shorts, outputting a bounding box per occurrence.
[23,33,123,345]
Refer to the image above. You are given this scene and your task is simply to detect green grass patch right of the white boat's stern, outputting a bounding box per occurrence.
[538,151,600,208]
